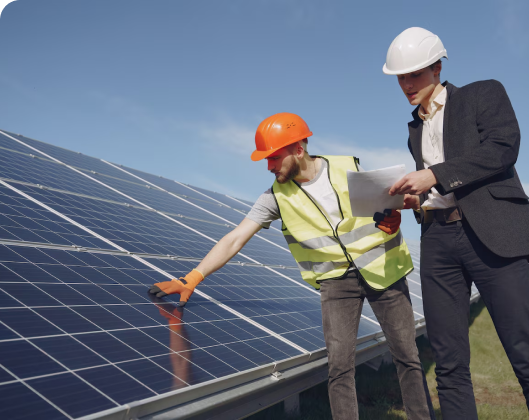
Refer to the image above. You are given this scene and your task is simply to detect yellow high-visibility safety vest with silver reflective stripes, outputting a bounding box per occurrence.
[272,156,413,290]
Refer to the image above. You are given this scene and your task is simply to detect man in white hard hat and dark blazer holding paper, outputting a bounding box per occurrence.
[383,28,529,420]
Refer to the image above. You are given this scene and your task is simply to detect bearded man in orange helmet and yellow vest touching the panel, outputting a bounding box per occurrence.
[150,113,435,420]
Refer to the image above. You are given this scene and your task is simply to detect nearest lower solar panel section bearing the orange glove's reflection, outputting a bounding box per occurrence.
[0,245,309,418]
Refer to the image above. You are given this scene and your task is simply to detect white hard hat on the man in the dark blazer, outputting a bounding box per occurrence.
[382,28,448,74]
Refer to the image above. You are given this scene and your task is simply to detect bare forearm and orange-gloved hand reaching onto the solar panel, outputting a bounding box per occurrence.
[149,218,261,306]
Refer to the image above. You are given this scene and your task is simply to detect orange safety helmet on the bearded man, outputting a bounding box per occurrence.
[252,112,312,161]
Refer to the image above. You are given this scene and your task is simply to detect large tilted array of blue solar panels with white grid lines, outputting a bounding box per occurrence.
[0,132,464,419]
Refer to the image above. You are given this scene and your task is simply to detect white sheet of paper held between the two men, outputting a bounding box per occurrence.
[347,165,406,217]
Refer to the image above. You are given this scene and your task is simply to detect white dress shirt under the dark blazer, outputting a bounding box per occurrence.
[419,88,456,210]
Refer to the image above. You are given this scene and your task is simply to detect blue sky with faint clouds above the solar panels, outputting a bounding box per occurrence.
[0,0,529,239]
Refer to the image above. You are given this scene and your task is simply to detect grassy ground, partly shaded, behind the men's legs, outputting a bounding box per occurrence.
[248,301,529,420]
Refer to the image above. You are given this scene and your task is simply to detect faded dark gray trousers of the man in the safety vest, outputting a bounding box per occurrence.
[321,273,435,420]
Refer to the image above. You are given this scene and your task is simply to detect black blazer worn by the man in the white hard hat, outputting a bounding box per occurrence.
[408,80,529,257]
